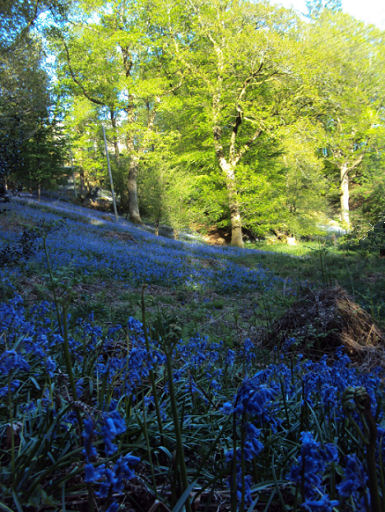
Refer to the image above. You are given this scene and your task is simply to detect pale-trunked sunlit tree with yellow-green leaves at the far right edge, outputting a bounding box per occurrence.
[308,11,384,229]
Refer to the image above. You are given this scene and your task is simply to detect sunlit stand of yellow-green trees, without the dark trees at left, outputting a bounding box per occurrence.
[39,0,384,242]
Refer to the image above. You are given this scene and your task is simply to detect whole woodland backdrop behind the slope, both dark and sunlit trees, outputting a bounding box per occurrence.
[0,0,385,246]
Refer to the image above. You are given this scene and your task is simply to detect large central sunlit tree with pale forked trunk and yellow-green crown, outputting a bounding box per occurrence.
[150,0,306,246]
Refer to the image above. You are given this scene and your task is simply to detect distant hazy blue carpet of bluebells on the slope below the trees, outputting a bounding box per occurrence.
[0,204,276,292]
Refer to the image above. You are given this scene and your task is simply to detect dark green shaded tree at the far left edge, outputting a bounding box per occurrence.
[0,34,63,192]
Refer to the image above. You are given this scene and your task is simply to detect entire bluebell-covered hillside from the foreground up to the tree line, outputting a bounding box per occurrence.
[0,200,385,512]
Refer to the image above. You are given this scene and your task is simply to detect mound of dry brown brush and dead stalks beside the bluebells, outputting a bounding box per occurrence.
[266,286,385,368]
